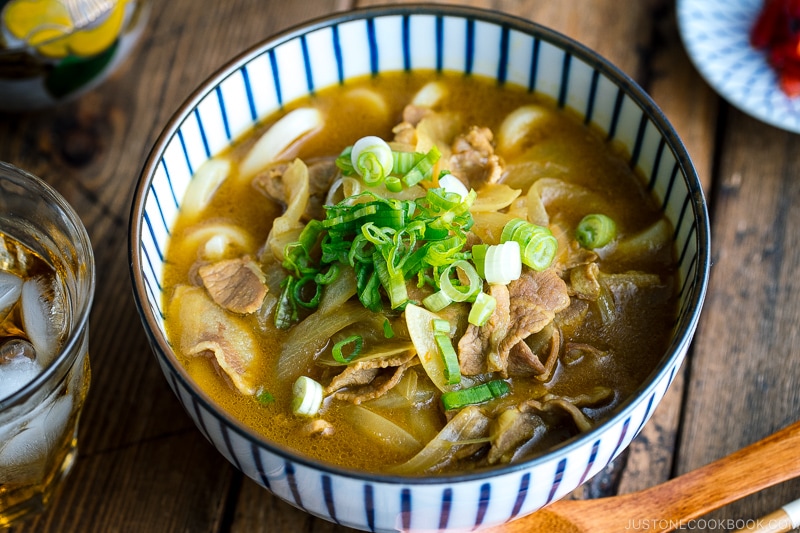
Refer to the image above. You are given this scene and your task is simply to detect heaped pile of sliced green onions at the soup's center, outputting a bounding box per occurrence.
[275,141,483,328]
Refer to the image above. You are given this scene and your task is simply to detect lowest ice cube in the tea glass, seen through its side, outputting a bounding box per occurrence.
[0,395,72,484]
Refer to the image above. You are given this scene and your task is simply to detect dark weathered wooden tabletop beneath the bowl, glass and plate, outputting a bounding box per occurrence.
[0,0,800,532]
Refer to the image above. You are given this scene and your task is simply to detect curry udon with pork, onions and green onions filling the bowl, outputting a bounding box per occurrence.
[164,72,677,475]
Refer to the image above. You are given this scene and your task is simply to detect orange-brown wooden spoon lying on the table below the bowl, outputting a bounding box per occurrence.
[485,422,800,533]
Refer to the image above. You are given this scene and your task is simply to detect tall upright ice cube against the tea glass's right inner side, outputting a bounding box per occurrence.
[22,276,66,366]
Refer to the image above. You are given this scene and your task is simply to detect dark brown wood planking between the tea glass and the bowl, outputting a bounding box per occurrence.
[0,0,340,531]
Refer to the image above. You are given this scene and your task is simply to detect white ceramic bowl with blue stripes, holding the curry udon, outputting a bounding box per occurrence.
[130,5,710,531]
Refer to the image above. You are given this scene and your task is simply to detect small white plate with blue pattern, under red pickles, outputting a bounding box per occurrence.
[676,0,800,133]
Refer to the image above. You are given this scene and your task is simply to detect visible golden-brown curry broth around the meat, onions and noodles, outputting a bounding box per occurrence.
[163,73,676,471]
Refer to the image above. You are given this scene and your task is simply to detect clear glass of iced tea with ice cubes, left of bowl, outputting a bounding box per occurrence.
[0,162,94,527]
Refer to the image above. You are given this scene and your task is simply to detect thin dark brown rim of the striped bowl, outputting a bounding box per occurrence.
[128,3,711,485]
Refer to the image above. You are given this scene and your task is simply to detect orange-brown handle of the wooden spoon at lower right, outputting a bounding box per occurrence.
[639,422,800,520]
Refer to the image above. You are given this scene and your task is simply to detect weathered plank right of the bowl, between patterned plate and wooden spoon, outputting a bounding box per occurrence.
[678,104,800,528]
